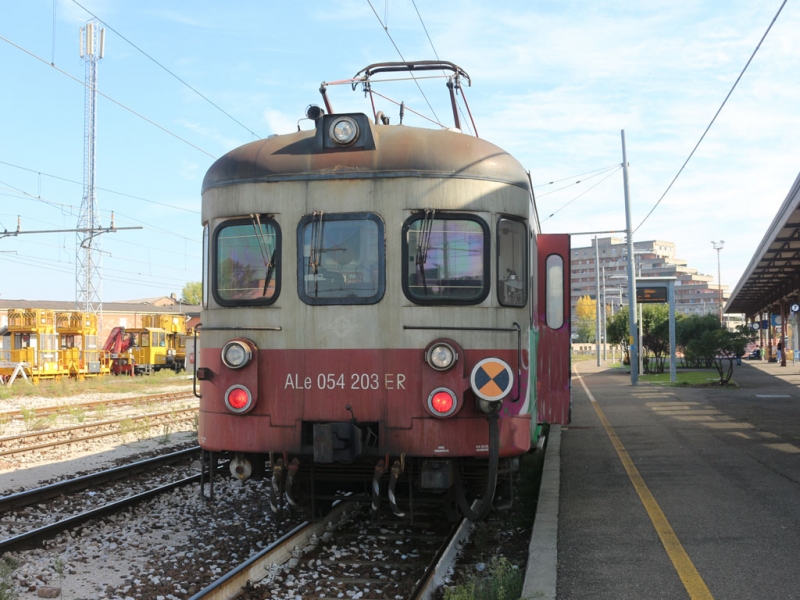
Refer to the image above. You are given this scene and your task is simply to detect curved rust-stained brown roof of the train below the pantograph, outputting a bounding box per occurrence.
[203,113,530,192]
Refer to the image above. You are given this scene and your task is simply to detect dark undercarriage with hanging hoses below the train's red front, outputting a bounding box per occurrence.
[194,451,520,522]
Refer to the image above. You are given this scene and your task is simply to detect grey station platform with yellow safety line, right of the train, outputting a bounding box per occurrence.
[522,361,800,600]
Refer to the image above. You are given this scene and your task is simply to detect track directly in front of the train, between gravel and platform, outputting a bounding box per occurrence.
[191,502,472,600]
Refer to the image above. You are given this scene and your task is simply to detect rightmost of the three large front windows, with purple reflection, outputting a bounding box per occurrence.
[403,210,489,304]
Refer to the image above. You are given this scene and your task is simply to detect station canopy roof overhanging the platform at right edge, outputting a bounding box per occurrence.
[725,175,800,317]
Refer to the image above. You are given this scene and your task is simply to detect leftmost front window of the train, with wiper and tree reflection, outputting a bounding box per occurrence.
[212,215,281,306]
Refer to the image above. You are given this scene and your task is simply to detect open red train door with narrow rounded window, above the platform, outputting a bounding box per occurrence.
[536,234,572,425]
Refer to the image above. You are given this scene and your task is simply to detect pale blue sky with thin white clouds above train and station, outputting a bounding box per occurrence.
[0,0,800,302]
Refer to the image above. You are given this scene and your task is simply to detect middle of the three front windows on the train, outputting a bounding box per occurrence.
[297,212,386,305]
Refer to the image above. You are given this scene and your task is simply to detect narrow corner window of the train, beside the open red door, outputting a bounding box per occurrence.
[497,217,528,306]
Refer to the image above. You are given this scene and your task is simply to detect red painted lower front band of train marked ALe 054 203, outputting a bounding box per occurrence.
[200,348,531,457]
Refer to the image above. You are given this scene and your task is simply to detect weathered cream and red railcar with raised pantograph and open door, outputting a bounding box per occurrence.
[193,60,571,521]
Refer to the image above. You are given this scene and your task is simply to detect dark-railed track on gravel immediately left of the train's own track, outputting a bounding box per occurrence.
[0,447,209,554]
